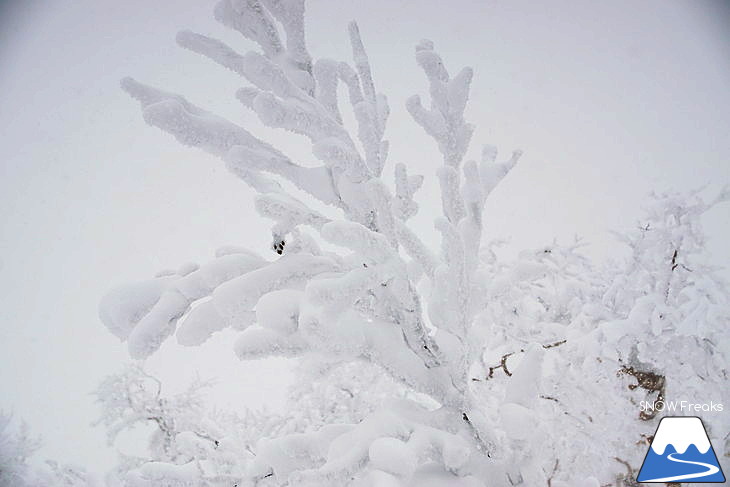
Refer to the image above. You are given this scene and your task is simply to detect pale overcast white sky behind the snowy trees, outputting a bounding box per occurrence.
[0,0,730,469]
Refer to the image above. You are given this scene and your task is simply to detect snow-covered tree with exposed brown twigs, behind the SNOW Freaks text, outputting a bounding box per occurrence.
[464,193,730,486]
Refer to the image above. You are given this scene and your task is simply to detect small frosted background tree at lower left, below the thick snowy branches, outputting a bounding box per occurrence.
[96,365,286,486]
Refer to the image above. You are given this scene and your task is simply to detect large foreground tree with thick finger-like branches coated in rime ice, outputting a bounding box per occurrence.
[108,0,519,481]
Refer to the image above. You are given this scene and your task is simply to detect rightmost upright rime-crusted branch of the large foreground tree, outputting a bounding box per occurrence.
[396,41,521,380]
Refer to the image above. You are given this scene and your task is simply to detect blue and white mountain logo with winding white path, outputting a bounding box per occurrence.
[636,416,725,483]
